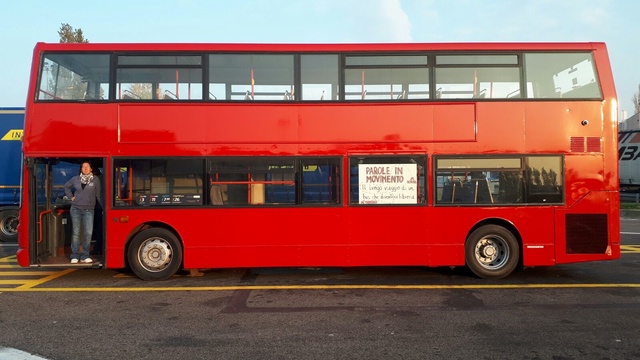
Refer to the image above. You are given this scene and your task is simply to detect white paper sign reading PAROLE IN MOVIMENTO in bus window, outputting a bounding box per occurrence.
[358,164,418,204]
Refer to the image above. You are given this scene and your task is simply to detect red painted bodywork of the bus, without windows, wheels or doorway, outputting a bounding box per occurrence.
[18,43,620,268]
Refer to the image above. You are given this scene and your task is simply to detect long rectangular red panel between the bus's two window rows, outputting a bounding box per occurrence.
[119,103,476,144]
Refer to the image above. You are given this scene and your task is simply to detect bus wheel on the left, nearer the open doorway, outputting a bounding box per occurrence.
[128,228,182,280]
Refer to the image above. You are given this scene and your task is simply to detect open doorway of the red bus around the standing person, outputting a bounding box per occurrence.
[29,158,105,267]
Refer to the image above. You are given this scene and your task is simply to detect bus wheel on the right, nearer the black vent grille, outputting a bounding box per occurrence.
[465,225,520,279]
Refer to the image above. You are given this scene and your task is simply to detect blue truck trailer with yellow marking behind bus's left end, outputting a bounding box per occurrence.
[0,107,24,242]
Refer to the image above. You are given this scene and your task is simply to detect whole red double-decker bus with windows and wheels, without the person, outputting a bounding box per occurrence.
[18,43,620,280]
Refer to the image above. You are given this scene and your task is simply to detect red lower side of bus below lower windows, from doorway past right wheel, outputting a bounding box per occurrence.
[107,207,555,268]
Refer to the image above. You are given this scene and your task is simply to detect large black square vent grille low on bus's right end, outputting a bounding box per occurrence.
[566,214,609,254]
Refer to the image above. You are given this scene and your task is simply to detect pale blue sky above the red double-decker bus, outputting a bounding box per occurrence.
[0,0,640,120]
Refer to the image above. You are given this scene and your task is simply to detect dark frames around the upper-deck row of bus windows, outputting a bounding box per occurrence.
[33,50,604,104]
